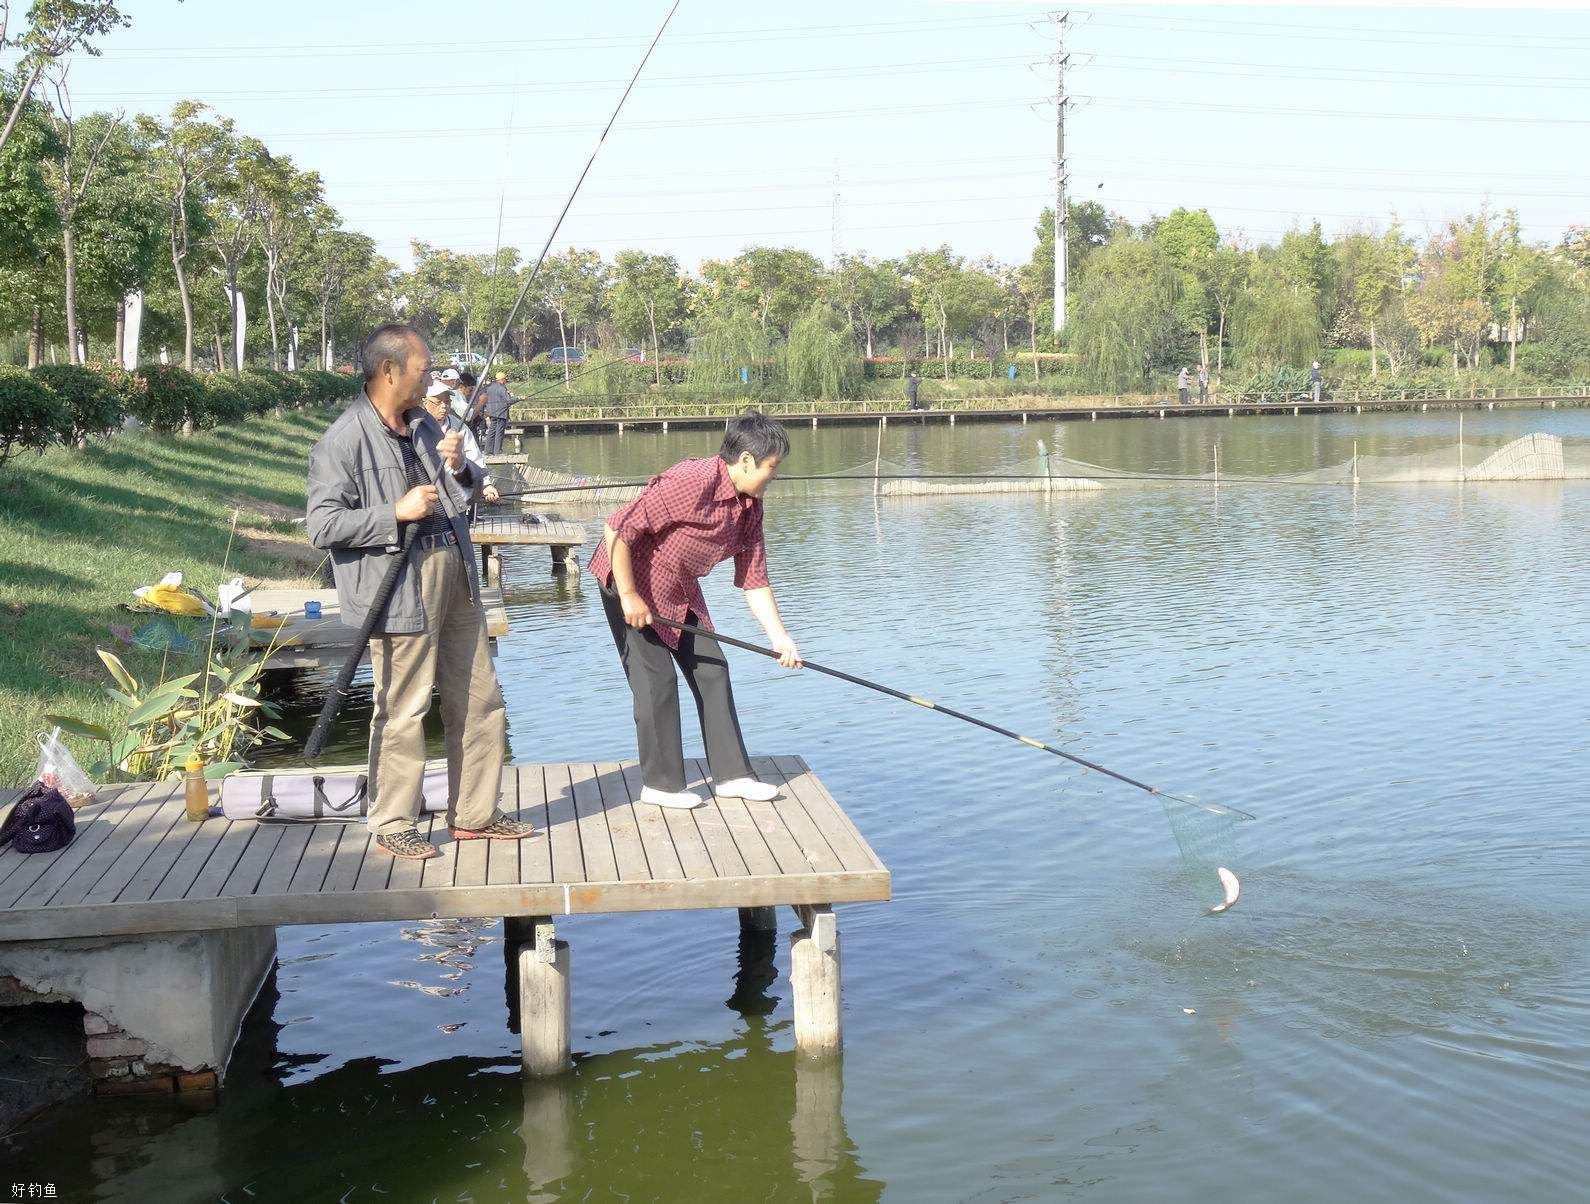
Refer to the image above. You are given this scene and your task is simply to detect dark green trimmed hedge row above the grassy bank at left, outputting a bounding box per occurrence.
[0,364,358,463]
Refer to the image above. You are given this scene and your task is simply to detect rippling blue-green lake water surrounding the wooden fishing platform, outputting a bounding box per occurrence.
[0,410,1590,1204]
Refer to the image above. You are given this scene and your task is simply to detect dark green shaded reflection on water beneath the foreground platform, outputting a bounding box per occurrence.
[6,922,882,1201]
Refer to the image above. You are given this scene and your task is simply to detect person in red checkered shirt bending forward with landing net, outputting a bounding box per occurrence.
[590,412,801,808]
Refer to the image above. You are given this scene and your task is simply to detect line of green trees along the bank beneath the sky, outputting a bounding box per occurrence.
[0,0,1590,396]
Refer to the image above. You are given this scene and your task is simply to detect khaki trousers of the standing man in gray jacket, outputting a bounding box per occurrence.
[369,547,507,835]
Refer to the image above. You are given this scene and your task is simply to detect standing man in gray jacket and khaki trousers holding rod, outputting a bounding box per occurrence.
[308,324,533,859]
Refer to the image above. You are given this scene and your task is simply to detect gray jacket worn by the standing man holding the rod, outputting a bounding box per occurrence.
[308,391,482,635]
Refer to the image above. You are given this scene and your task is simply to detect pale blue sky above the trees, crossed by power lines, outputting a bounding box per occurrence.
[21,0,1590,269]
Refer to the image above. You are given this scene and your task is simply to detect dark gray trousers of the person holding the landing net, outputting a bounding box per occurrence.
[601,590,750,790]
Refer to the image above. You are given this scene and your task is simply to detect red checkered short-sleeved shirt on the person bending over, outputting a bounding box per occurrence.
[590,456,770,647]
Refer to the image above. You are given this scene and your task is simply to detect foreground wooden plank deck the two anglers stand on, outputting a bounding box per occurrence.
[0,757,890,940]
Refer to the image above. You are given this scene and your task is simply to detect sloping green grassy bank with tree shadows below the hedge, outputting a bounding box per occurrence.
[0,409,334,786]
